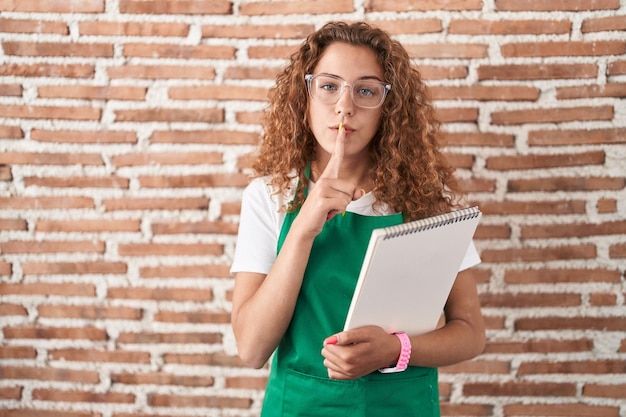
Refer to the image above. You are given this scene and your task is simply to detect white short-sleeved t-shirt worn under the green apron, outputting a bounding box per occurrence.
[230,177,480,274]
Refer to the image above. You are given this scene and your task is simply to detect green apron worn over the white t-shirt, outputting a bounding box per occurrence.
[261,180,439,417]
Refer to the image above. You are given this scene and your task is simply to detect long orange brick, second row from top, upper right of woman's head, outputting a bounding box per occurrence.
[448,19,572,35]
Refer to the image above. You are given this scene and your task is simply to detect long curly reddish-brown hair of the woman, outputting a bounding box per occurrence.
[253,22,460,221]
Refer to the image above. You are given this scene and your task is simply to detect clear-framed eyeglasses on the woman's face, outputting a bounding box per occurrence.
[304,74,391,109]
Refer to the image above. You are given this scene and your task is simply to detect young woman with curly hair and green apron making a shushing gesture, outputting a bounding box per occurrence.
[232,22,485,417]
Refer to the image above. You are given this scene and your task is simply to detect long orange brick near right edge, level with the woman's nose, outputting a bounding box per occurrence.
[491,105,614,125]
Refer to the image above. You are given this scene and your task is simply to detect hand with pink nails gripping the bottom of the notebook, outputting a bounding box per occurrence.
[322,326,400,379]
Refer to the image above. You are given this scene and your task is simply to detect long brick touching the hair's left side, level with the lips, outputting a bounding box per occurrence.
[150,130,259,145]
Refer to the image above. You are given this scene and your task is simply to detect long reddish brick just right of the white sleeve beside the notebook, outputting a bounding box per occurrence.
[481,244,597,263]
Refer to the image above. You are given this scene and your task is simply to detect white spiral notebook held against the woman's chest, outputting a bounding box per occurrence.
[344,207,481,335]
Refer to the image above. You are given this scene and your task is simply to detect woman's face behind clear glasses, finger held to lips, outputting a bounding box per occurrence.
[309,42,385,158]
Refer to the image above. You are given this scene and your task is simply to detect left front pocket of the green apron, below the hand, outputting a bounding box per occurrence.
[283,369,366,417]
